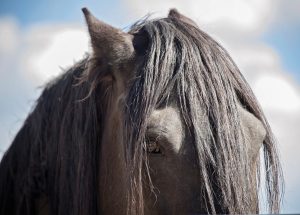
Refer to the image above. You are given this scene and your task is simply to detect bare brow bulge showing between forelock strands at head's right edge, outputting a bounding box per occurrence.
[238,105,266,159]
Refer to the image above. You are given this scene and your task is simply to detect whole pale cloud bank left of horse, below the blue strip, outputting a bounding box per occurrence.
[0,17,89,159]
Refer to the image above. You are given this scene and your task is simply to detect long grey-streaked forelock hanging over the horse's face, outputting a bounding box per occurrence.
[125,18,282,214]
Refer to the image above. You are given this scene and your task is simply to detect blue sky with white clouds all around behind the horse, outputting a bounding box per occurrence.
[0,0,300,213]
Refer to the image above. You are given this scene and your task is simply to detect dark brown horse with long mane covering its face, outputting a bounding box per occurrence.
[0,8,283,215]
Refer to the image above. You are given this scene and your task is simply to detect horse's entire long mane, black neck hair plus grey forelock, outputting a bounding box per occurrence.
[0,15,281,215]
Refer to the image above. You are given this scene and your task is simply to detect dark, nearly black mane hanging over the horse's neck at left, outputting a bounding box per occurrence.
[0,59,102,215]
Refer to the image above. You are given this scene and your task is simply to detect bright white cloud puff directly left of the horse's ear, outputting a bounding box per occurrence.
[21,25,89,83]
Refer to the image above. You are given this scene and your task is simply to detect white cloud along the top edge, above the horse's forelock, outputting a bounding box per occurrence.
[124,0,277,31]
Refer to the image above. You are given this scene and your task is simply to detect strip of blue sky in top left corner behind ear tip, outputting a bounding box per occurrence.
[0,0,128,27]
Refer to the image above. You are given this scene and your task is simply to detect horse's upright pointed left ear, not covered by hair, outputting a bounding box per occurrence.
[82,8,134,61]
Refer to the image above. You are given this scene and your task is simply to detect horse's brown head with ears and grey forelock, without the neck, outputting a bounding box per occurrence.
[83,9,278,214]
